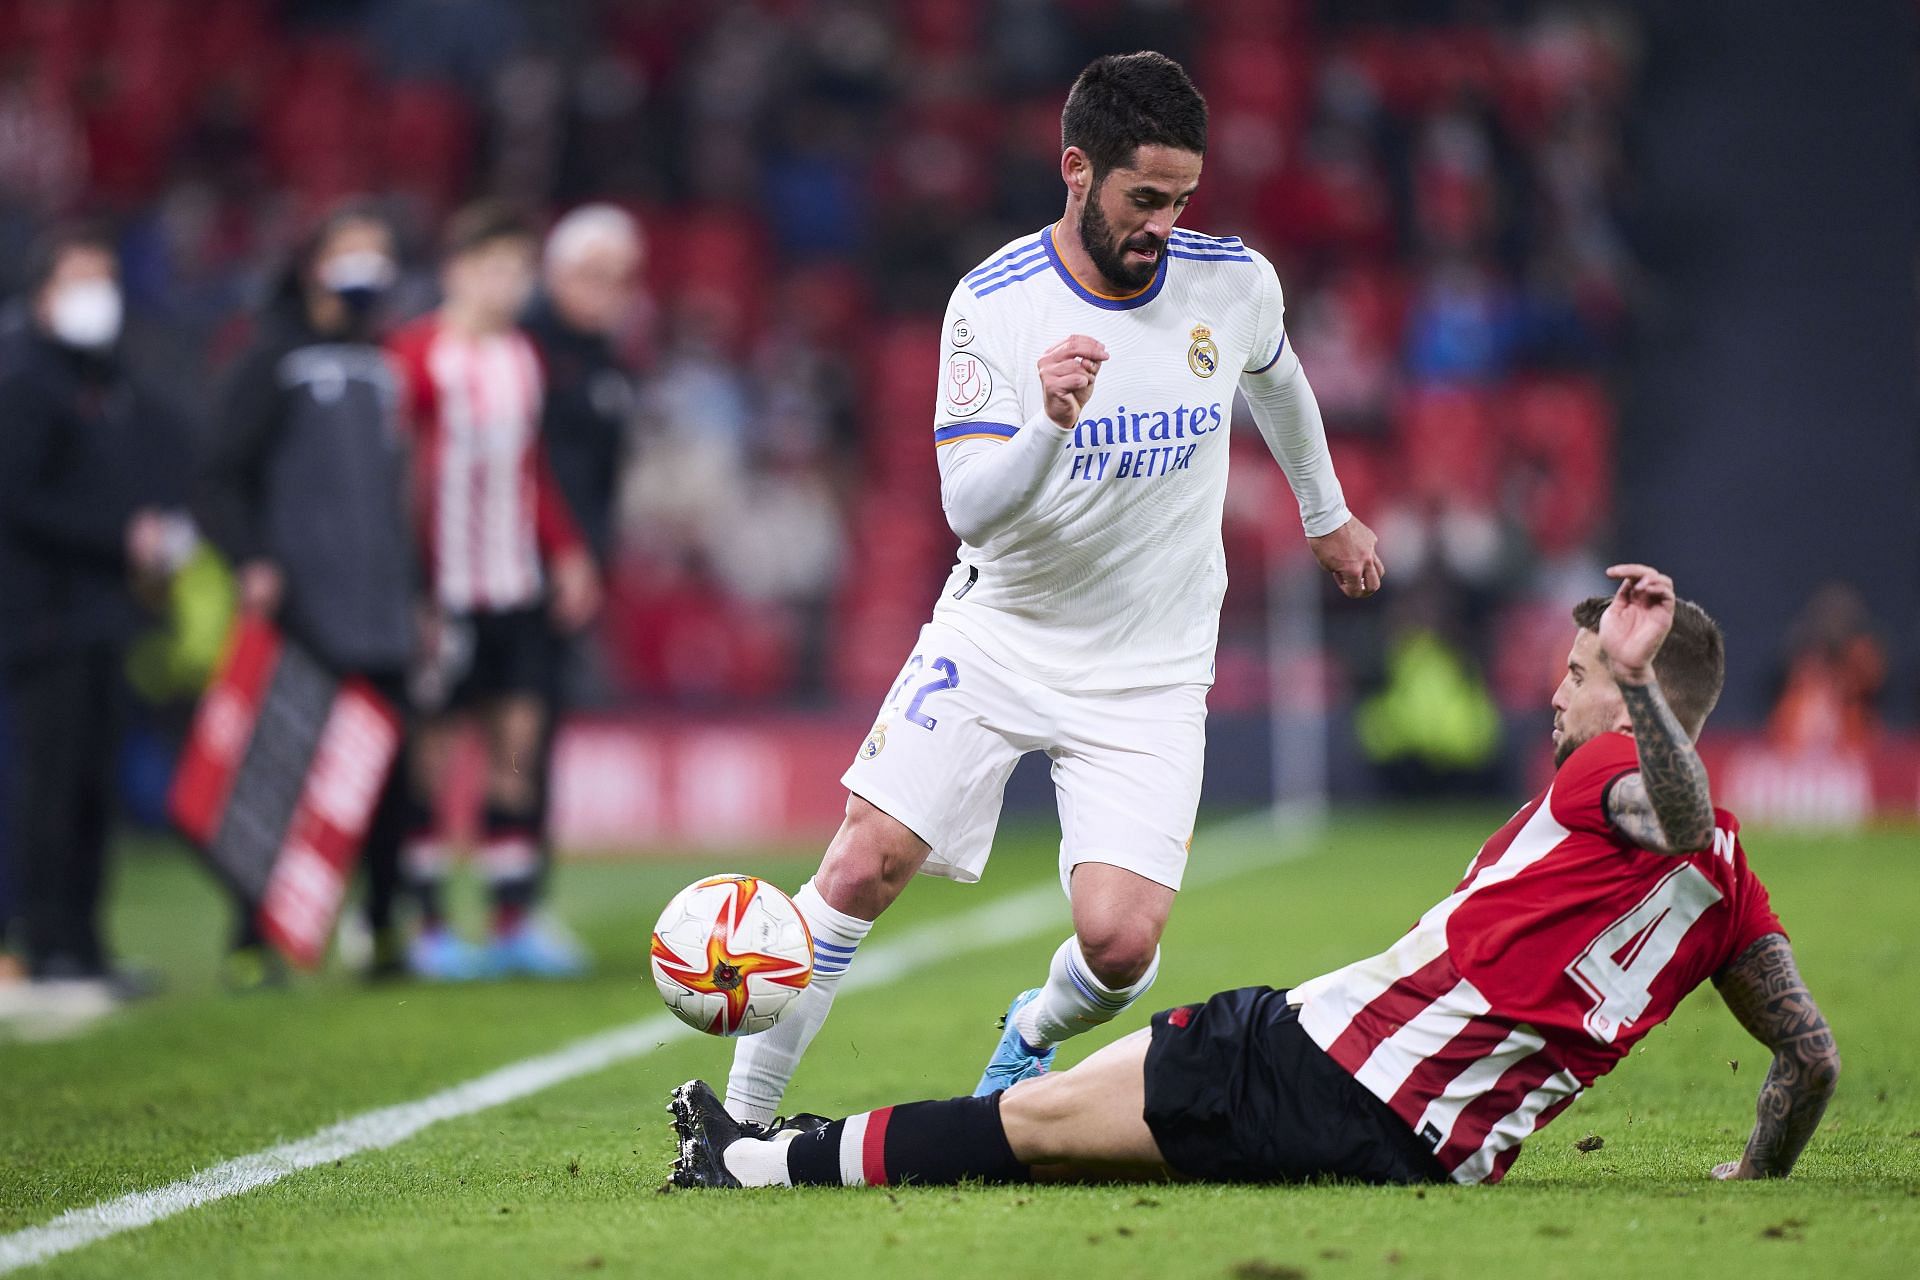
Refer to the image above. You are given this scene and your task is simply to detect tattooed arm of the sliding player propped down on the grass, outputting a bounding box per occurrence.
[1713,933,1839,1178]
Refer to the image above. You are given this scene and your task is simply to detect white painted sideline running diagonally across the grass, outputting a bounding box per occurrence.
[0,823,1309,1274]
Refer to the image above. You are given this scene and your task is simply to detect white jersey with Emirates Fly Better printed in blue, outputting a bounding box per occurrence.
[933,228,1292,691]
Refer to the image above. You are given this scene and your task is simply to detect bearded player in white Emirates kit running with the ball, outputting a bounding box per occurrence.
[726,52,1384,1125]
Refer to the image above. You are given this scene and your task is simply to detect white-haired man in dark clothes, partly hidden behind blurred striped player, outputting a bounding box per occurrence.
[520,203,645,909]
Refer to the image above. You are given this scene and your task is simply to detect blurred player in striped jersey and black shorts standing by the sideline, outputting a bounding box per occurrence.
[390,201,601,981]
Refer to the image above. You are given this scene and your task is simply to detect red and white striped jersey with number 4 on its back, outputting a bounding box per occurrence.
[1290,733,1784,1182]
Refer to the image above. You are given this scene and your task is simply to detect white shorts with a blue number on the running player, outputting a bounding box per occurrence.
[841,622,1208,892]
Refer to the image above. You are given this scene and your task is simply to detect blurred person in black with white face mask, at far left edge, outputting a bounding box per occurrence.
[0,228,198,1017]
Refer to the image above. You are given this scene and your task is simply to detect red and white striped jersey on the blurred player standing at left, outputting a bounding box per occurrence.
[388,315,580,612]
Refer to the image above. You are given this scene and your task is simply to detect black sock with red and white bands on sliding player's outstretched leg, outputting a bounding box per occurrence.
[787,1094,1033,1186]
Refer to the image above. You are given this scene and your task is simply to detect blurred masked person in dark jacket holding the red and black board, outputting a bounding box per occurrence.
[200,205,420,988]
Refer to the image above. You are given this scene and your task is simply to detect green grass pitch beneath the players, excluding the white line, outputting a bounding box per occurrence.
[0,810,1920,1280]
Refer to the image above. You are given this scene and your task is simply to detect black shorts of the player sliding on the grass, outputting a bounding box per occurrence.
[1146,986,1448,1182]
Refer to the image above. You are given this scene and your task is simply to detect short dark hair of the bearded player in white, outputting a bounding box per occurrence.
[1060,52,1206,182]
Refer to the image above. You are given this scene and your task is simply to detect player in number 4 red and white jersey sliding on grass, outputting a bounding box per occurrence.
[670,564,1839,1186]
